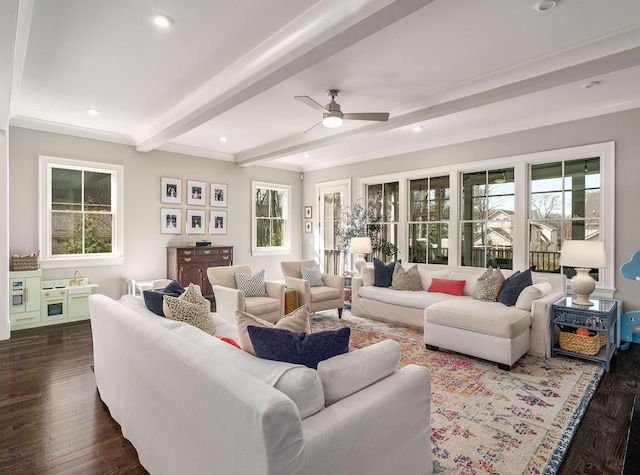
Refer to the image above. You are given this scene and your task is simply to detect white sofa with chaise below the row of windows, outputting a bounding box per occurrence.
[351,264,566,366]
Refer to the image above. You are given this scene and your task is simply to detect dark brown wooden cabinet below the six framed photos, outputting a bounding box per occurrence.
[167,246,233,297]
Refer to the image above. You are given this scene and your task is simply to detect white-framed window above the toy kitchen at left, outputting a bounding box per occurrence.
[40,157,123,268]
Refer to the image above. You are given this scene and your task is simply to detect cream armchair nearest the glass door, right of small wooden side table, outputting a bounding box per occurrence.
[280,259,344,318]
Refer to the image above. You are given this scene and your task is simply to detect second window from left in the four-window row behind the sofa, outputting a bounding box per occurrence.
[408,176,451,264]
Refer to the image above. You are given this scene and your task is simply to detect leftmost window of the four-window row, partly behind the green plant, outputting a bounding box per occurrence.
[367,181,400,262]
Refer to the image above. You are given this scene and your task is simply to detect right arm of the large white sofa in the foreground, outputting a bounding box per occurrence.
[299,365,432,475]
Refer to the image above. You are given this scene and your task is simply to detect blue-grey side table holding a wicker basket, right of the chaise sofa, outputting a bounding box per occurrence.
[551,296,619,371]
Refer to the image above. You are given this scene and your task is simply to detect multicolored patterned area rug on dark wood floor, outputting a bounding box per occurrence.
[312,312,604,475]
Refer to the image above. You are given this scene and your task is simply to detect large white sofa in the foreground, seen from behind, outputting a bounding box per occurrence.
[89,295,432,475]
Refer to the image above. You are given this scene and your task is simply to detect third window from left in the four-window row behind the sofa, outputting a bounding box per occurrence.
[461,168,515,269]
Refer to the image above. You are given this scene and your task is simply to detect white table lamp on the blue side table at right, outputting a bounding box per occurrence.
[560,240,607,307]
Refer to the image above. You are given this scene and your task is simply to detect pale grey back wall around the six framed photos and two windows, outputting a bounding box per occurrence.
[6,127,304,302]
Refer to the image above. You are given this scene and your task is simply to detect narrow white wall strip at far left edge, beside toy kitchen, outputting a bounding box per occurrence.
[0,130,10,340]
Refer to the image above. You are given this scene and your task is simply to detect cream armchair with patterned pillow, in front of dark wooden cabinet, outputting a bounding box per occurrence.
[207,265,284,324]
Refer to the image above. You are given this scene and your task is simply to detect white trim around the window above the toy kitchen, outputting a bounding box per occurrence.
[38,155,124,269]
